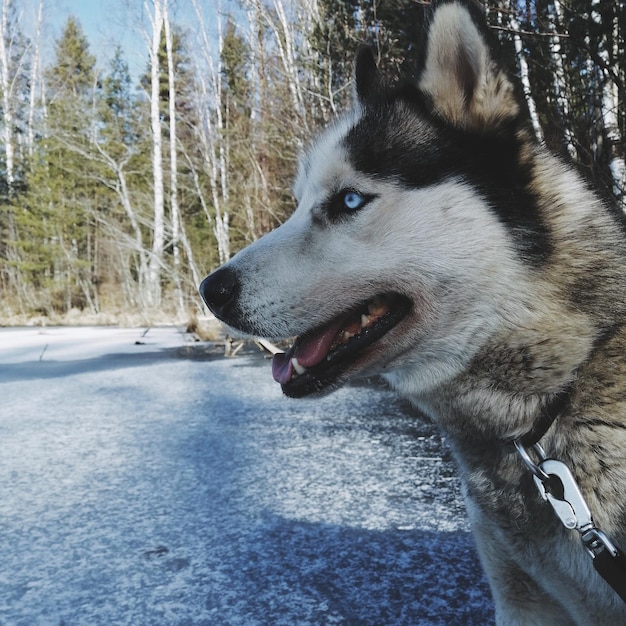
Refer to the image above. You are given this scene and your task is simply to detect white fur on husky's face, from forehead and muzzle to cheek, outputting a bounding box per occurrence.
[229,119,536,395]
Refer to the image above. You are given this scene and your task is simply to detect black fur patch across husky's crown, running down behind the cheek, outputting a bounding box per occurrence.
[344,84,551,267]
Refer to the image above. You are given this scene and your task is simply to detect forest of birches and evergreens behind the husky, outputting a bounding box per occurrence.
[0,0,626,324]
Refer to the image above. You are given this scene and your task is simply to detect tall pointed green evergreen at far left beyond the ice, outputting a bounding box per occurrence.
[19,17,101,313]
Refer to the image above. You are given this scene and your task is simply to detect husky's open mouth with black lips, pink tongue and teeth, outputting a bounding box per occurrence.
[272,293,411,398]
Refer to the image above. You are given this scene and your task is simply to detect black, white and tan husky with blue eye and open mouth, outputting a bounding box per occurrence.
[201,0,626,626]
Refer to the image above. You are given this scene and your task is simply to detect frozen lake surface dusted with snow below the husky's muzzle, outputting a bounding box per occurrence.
[0,328,493,626]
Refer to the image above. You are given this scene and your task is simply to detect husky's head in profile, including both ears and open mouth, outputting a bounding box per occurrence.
[200,2,546,396]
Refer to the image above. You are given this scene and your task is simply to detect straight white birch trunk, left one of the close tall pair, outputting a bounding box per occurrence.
[144,0,167,308]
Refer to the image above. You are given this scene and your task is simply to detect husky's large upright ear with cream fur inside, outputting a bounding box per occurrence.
[419,1,520,132]
